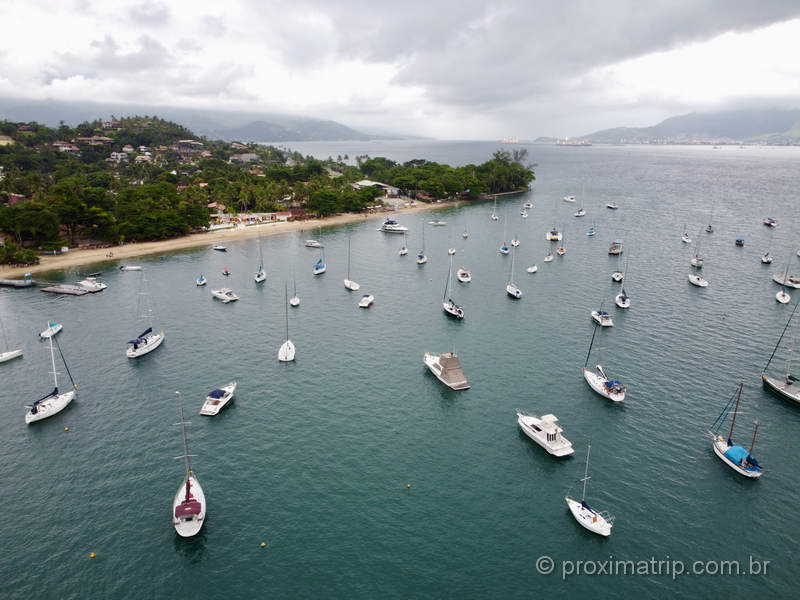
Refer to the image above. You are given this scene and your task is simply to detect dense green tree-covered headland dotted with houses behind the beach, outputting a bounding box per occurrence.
[0,116,534,263]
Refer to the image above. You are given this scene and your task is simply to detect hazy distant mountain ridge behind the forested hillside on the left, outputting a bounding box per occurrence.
[0,98,390,142]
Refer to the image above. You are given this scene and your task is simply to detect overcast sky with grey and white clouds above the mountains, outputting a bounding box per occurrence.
[0,0,800,139]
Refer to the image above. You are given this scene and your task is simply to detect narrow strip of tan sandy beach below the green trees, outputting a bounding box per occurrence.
[0,201,459,279]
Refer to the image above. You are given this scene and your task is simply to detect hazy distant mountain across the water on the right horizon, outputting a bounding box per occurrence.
[579,108,800,144]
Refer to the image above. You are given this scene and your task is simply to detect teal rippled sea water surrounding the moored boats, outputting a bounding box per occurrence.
[0,142,800,598]
